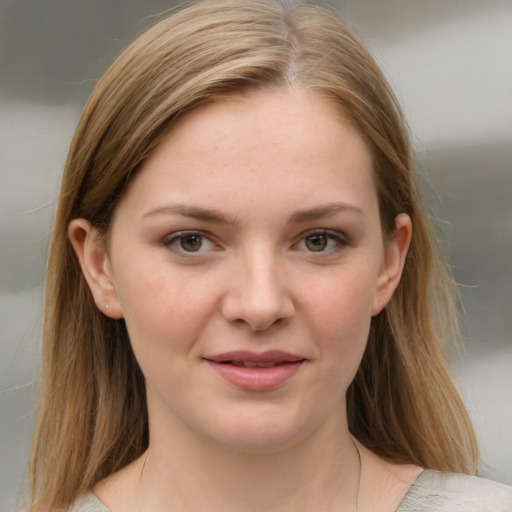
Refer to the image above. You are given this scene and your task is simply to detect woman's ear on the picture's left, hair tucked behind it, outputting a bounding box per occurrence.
[68,219,123,319]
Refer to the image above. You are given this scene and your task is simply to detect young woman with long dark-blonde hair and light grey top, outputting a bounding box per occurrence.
[29,0,512,512]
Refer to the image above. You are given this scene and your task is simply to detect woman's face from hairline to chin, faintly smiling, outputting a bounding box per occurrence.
[70,90,410,451]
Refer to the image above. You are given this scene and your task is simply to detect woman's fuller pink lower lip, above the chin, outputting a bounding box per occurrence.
[208,361,303,391]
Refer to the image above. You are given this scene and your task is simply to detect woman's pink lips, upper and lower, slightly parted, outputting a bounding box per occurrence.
[204,350,305,391]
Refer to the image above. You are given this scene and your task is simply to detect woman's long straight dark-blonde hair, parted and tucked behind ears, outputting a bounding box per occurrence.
[30,0,478,512]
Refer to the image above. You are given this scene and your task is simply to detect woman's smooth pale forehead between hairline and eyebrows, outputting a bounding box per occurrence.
[116,89,376,220]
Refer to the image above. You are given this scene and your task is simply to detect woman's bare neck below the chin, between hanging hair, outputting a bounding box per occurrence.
[136,414,360,512]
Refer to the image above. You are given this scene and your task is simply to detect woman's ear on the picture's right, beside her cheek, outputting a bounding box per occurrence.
[372,213,412,316]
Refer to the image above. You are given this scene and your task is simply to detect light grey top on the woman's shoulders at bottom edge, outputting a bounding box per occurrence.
[69,469,512,512]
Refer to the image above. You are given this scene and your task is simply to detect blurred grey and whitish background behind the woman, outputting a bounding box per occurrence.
[0,0,512,510]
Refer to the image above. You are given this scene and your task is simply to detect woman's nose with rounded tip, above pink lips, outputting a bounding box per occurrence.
[222,249,295,331]
